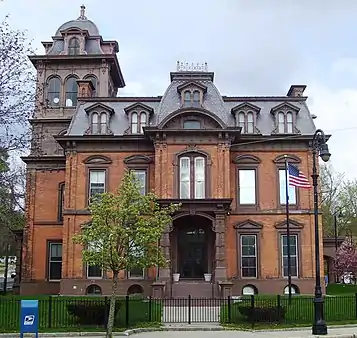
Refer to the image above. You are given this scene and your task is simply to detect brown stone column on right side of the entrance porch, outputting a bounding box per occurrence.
[214,211,227,281]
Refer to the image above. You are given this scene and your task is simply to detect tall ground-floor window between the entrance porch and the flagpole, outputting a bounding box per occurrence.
[240,235,257,278]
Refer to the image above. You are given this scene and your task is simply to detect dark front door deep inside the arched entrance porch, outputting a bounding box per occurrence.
[178,227,208,279]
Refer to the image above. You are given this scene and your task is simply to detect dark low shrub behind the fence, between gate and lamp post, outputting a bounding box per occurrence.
[238,306,286,322]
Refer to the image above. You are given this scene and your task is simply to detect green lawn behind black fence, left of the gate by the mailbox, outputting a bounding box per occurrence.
[0,296,162,332]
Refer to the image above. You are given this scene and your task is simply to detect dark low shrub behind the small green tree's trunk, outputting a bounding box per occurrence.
[67,300,122,326]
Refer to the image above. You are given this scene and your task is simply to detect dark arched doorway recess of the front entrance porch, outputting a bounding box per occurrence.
[173,215,214,279]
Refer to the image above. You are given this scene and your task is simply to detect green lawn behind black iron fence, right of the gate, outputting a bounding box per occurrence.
[221,295,357,327]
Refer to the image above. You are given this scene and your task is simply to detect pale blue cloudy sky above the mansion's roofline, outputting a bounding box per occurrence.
[0,0,357,179]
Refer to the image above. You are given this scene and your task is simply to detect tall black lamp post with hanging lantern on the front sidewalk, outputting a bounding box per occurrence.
[311,129,331,335]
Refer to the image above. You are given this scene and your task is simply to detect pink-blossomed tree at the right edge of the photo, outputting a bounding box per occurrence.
[334,238,357,282]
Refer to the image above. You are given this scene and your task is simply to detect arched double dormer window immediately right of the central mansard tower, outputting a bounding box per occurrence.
[231,103,260,134]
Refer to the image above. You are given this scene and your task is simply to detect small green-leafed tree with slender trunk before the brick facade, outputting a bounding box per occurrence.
[73,171,179,337]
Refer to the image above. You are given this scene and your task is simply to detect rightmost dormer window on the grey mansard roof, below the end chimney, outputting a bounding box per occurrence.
[271,103,300,134]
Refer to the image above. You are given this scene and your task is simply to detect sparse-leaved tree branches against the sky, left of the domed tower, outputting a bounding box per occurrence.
[0,16,36,151]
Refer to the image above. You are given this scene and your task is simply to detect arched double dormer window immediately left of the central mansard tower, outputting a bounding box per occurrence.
[124,103,154,134]
